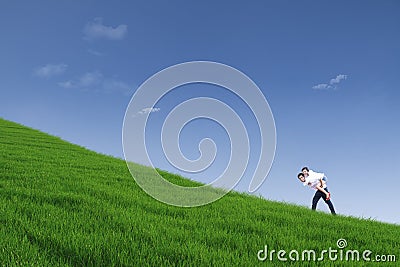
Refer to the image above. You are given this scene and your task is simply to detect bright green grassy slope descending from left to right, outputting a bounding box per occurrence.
[0,119,400,266]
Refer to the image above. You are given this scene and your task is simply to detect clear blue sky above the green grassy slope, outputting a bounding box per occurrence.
[0,1,400,223]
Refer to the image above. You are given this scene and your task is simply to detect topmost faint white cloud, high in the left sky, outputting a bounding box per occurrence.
[83,18,128,40]
